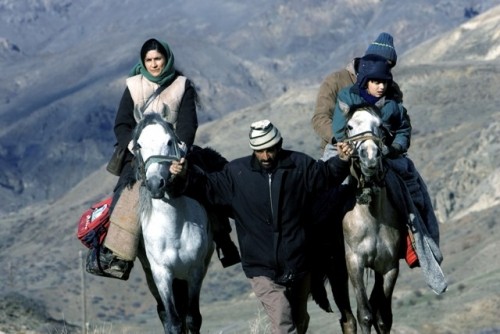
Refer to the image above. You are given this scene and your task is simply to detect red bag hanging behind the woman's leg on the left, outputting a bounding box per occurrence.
[76,196,113,248]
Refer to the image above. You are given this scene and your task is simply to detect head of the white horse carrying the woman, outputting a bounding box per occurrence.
[133,113,184,199]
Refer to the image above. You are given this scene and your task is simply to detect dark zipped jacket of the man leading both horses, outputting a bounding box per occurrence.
[187,150,349,280]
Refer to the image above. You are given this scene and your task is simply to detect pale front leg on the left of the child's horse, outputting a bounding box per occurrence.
[346,250,373,334]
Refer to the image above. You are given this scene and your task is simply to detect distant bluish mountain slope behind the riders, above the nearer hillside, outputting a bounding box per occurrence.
[0,0,495,212]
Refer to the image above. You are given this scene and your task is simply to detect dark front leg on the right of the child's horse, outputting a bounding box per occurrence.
[370,267,399,333]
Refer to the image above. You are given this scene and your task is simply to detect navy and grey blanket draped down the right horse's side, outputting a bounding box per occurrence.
[386,157,448,294]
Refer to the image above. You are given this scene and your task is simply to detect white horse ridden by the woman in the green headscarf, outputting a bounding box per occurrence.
[133,113,214,333]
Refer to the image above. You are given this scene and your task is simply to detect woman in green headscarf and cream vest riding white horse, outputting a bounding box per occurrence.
[96,39,240,279]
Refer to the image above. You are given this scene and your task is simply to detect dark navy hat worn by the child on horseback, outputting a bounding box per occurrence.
[356,54,392,89]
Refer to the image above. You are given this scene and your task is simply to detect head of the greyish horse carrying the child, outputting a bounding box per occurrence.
[346,106,383,178]
